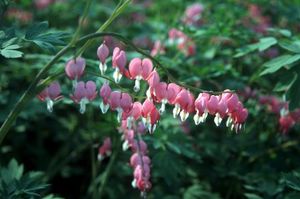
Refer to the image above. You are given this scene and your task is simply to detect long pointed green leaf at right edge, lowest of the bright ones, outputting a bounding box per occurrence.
[260,54,300,75]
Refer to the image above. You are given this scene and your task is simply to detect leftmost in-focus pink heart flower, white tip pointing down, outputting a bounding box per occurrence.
[37,82,62,112]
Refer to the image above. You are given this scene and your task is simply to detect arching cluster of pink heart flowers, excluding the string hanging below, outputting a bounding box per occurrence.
[38,43,248,133]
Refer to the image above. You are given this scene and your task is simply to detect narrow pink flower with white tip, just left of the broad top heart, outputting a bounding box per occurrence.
[112,47,127,83]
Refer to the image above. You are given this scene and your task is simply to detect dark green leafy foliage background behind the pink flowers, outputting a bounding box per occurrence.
[0,0,300,199]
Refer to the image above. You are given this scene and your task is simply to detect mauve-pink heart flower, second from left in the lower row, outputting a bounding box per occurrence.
[71,81,97,114]
